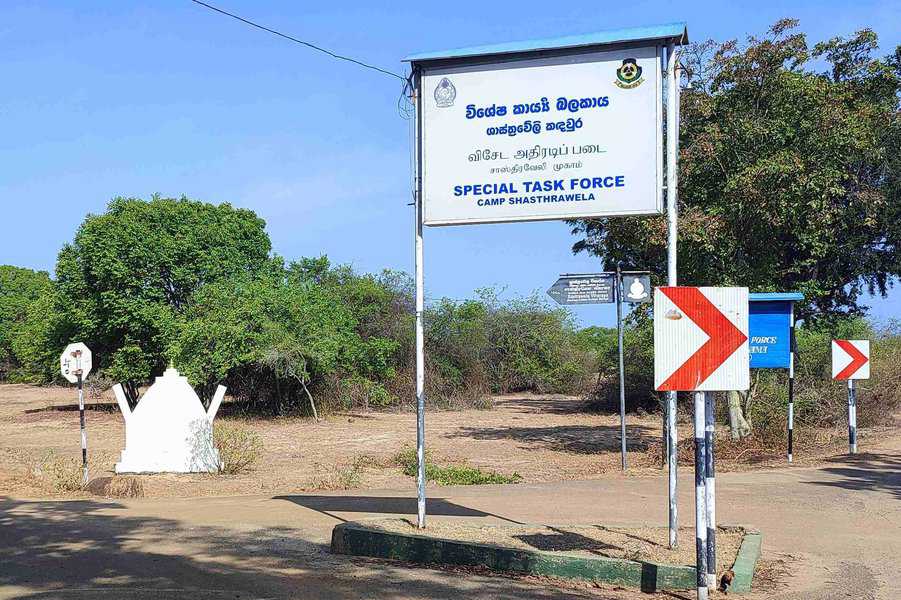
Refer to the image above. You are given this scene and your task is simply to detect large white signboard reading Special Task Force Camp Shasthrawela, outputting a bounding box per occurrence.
[421,46,663,225]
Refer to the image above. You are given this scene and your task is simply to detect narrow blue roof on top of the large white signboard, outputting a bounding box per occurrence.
[403,23,688,62]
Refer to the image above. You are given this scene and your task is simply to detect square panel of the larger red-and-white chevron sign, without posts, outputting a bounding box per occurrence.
[654,287,751,392]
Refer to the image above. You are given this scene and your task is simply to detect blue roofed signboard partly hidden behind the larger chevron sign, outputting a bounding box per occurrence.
[748,293,804,369]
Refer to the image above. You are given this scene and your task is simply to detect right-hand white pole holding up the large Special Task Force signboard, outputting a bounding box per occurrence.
[666,44,679,548]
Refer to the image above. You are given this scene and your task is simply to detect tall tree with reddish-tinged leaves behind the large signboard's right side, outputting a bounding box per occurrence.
[572,20,901,320]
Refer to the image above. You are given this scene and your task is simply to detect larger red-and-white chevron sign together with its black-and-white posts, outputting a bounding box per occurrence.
[654,287,751,599]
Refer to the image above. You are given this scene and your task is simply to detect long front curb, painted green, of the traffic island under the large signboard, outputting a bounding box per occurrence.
[332,522,696,592]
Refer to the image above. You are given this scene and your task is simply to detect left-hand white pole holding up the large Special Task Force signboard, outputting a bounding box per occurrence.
[413,71,426,529]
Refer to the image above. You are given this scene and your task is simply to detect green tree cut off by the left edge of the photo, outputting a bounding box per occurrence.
[0,265,53,380]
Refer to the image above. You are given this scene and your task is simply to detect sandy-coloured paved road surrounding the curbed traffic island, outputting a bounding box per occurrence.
[0,440,901,600]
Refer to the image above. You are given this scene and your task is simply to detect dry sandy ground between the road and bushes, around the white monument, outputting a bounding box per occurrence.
[0,385,866,497]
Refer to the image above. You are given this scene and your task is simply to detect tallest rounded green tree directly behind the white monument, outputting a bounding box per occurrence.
[50,197,276,401]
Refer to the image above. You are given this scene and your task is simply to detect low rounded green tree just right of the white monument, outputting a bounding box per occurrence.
[172,278,363,417]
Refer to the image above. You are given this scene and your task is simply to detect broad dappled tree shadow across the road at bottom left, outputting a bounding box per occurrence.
[0,498,581,599]
